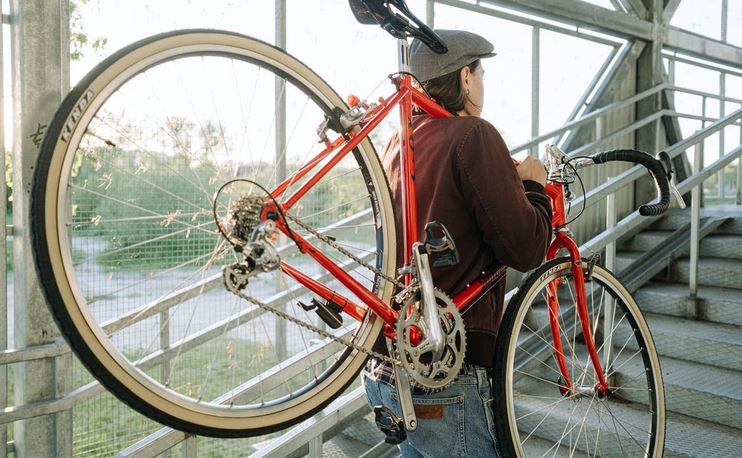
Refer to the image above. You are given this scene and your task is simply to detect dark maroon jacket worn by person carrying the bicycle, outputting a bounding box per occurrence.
[382,115,551,367]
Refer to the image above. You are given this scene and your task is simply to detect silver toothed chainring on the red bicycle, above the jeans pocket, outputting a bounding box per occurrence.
[395,289,466,391]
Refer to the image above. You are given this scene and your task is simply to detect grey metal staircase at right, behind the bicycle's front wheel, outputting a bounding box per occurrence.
[618,206,742,457]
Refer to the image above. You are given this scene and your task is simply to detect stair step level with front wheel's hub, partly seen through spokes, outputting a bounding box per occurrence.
[614,349,742,428]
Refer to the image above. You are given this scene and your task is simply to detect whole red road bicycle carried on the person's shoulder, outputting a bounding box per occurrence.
[32,0,668,456]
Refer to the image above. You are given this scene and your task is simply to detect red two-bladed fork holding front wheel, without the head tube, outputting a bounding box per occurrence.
[546,232,610,396]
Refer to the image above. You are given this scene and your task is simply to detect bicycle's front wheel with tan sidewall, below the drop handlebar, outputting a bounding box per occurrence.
[494,258,665,457]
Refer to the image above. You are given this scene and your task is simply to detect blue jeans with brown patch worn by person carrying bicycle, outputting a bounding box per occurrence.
[363,366,502,458]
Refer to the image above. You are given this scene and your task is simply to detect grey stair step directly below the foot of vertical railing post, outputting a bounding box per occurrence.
[632,313,742,374]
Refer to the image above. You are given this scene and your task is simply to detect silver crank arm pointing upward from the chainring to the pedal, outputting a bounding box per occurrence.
[412,242,446,361]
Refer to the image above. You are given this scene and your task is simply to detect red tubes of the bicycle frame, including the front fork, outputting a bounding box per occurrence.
[264,40,608,393]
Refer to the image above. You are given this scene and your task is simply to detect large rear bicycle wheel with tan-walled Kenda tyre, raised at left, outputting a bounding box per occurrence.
[32,30,396,437]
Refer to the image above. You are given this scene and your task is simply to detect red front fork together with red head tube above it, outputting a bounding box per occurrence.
[546,182,608,393]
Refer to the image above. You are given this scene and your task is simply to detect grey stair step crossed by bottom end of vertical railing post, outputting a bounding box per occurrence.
[634,282,742,326]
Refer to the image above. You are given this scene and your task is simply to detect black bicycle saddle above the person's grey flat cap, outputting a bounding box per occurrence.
[348,0,448,54]
